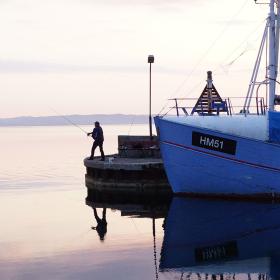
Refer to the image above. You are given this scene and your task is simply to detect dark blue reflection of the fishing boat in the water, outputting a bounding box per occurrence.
[160,198,280,279]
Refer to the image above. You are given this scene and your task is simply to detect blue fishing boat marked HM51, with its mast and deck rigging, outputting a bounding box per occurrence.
[155,0,280,198]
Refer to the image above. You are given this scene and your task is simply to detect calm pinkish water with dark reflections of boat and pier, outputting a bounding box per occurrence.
[0,125,280,280]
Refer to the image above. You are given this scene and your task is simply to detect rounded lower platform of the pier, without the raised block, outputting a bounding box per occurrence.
[84,155,171,194]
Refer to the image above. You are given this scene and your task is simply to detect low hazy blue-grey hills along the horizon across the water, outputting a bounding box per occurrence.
[0,114,151,126]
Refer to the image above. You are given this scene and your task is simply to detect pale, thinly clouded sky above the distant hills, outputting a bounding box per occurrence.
[0,0,268,118]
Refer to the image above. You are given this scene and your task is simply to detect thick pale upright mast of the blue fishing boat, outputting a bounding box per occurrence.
[268,0,279,111]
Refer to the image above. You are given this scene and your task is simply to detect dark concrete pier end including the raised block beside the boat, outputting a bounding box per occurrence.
[84,136,171,195]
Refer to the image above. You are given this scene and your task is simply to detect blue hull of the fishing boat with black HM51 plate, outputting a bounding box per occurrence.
[155,117,280,198]
